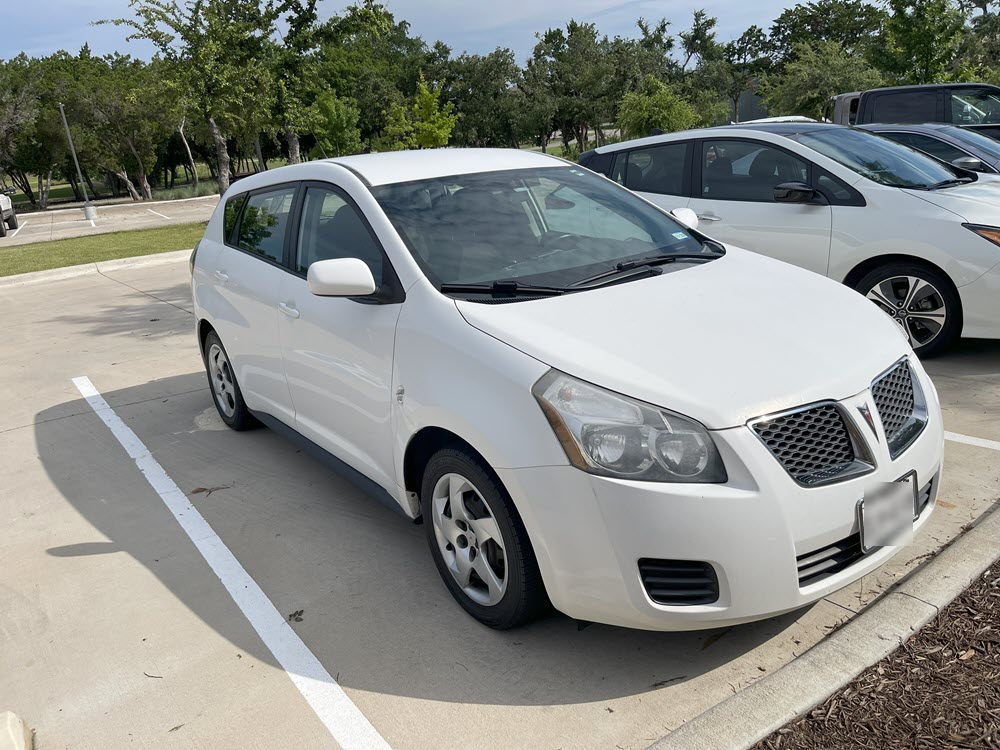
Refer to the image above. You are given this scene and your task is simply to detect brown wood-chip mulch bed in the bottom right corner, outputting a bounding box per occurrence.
[755,563,1000,750]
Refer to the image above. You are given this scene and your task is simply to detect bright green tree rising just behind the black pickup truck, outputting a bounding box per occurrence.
[875,0,966,83]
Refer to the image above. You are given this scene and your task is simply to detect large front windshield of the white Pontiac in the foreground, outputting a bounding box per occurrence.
[372,166,717,286]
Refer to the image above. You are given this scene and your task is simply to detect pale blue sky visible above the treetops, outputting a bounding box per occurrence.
[0,0,795,62]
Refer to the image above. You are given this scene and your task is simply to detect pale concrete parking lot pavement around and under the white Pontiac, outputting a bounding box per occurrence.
[0,256,1000,750]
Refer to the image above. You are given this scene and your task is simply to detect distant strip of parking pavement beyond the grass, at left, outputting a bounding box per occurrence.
[0,195,219,248]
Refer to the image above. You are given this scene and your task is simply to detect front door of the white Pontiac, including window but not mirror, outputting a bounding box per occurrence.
[279,183,402,489]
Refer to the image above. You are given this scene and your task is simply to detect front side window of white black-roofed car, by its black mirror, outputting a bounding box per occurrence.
[700,140,809,201]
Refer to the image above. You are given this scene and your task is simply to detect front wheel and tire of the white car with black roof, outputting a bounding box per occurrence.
[854,262,962,359]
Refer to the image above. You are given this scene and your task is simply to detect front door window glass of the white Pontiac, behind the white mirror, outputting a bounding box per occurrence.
[295,187,382,283]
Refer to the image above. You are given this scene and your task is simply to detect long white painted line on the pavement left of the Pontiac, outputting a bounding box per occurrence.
[73,377,389,750]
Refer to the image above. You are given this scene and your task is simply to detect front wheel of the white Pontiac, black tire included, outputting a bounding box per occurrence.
[420,445,549,630]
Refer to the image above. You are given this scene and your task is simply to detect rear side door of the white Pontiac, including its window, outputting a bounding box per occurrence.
[213,184,296,425]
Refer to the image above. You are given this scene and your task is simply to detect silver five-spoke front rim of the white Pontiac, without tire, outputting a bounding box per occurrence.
[431,473,507,607]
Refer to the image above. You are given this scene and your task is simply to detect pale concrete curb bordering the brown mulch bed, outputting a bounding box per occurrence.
[649,506,1000,750]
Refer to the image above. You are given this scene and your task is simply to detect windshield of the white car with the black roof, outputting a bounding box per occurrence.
[791,128,958,188]
